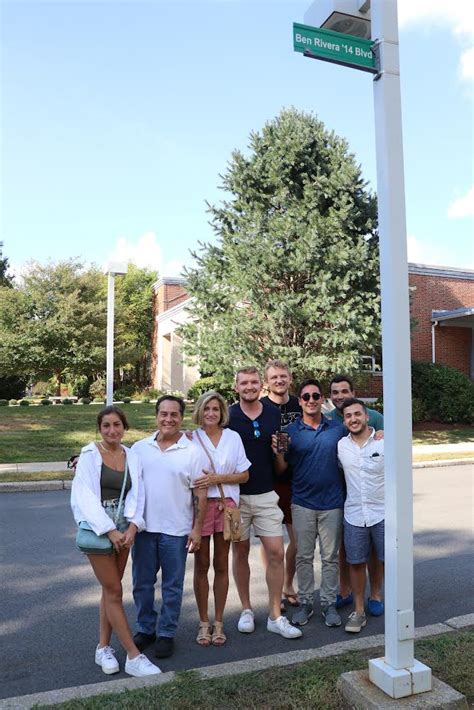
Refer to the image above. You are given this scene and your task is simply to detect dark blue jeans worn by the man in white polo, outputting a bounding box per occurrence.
[132,532,188,638]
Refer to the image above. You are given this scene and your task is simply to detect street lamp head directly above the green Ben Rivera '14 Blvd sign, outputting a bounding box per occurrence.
[304,0,370,39]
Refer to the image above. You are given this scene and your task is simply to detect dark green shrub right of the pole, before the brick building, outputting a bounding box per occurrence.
[412,362,474,424]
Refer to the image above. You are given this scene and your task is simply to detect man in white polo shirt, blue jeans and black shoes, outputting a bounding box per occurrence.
[132,395,208,658]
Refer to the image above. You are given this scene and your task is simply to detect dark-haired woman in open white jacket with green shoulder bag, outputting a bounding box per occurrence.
[71,406,160,676]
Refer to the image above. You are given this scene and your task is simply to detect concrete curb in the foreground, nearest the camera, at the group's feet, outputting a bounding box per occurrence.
[0,614,474,710]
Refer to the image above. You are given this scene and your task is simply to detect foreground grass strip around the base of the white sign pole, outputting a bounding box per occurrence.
[41,630,474,710]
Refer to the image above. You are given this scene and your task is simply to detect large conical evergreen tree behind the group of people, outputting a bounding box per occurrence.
[182,109,380,384]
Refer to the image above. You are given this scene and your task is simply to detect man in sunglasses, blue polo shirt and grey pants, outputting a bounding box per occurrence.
[274,379,345,626]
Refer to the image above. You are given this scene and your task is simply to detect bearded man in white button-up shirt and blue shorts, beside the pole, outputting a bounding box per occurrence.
[338,397,385,633]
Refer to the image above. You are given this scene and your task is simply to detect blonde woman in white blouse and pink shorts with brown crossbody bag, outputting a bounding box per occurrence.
[193,391,250,646]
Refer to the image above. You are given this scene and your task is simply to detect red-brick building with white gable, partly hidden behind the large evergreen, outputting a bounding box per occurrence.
[152,264,474,397]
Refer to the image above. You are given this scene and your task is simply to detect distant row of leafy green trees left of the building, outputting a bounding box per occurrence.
[0,257,157,398]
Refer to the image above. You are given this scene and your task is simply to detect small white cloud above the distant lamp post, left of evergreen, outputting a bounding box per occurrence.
[110,232,183,276]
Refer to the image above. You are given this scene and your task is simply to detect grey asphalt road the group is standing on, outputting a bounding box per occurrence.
[0,466,474,697]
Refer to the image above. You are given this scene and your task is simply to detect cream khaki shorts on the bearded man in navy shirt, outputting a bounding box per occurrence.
[239,491,283,540]
